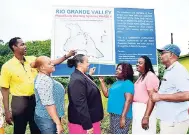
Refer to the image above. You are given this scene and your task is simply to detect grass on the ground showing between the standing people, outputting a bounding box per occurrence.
[5,92,189,134]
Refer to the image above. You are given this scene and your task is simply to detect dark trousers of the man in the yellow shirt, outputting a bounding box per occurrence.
[11,95,40,134]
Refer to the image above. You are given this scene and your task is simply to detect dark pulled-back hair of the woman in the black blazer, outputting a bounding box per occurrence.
[67,54,85,68]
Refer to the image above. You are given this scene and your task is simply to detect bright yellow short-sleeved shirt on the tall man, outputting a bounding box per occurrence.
[0,56,37,96]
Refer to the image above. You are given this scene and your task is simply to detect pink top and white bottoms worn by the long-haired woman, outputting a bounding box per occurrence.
[132,71,159,134]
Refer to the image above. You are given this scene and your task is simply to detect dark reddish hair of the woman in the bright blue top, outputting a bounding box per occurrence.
[117,62,134,82]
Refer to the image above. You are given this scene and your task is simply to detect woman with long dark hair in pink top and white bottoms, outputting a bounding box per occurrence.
[132,56,159,134]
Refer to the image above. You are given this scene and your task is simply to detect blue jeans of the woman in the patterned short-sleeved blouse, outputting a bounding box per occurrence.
[34,114,57,134]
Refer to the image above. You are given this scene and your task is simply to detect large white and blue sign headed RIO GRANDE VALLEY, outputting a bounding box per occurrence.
[51,7,157,76]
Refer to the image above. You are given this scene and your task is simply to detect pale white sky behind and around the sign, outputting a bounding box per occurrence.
[0,0,189,55]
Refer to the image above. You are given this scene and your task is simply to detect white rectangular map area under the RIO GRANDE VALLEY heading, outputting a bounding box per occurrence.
[51,11,115,64]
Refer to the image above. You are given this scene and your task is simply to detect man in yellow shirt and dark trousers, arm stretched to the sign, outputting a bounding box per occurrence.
[0,37,75,134]
